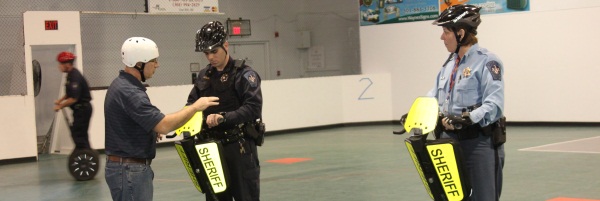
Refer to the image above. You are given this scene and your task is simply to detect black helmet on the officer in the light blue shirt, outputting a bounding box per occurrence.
[433,4,481,30]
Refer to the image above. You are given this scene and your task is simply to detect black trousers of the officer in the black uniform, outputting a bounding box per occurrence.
[206,137,260,201]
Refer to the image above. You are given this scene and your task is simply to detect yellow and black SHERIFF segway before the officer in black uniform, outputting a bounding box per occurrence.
[166,112,229,200]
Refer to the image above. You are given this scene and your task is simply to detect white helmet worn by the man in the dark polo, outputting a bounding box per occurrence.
[121,37,158,67]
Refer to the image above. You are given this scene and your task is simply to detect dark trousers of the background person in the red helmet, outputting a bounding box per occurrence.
[71,103,92,149]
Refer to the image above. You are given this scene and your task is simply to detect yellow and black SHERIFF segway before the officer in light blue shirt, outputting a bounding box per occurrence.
[394,97,471,201]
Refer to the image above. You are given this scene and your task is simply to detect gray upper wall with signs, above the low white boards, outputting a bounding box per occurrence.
[0,0,360,91]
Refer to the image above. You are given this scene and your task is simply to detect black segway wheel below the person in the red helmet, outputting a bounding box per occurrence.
[68,149,100,181]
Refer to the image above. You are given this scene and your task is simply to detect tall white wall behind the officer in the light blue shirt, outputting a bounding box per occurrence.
[360,0,600,122]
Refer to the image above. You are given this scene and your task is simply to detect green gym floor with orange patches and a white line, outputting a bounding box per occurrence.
[0,125,600,201]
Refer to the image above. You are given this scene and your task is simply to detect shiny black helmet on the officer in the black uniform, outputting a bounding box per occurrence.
[196,21,227,52]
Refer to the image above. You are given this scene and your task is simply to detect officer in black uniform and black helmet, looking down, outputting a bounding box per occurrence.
[188,21,262,201]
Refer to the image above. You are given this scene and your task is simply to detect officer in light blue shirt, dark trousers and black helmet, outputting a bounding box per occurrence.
[428,5,504,201]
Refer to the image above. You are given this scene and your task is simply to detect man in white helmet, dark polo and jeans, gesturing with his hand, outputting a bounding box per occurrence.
[104,37,219,200]
